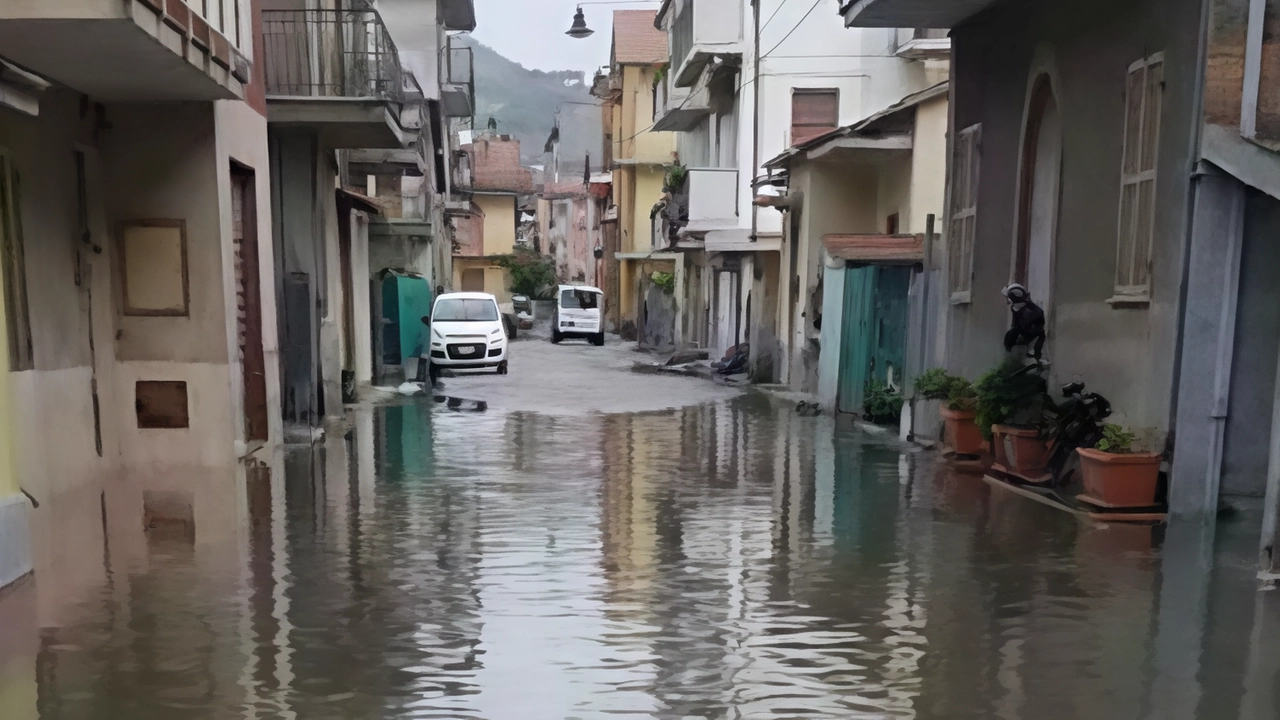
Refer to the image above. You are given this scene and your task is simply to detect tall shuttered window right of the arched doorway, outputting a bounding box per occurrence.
[1112,54,1165,301]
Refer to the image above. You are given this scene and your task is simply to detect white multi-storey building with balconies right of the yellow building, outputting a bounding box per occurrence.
[654,0,948,382]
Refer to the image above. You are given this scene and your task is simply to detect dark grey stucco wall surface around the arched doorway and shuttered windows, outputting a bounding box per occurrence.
[947,0,1201,448]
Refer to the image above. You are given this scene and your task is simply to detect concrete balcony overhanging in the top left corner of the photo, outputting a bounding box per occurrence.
[0,0,250,102]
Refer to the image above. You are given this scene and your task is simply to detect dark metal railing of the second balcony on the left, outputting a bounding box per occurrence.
[262,10,404,101]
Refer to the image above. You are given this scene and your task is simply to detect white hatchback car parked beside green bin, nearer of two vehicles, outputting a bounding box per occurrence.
[431,292,507,375]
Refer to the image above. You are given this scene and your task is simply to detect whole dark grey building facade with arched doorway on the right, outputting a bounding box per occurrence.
[845,0,1280,571]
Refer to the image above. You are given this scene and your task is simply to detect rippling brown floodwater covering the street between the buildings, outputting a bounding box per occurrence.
[0,395,1280,720]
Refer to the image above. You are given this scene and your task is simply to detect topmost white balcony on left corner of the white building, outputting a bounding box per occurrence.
[666,0,744,87]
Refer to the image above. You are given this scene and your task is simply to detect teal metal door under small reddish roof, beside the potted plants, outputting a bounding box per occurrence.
[838,265,911,414]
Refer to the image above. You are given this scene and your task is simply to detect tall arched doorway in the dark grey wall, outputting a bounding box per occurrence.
[1014,76,1062,313]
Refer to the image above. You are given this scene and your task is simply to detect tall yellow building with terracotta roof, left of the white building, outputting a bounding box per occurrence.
[595,10,676,338]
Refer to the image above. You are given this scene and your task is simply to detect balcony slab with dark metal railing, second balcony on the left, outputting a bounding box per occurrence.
[262,10,415,149]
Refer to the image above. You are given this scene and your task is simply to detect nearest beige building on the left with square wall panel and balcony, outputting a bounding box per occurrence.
[0,0,282,589]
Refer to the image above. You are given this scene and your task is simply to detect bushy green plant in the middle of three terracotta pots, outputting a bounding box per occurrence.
[974,359,1052,482]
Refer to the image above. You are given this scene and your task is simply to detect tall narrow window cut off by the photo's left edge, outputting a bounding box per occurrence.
[0,150,35,372]
